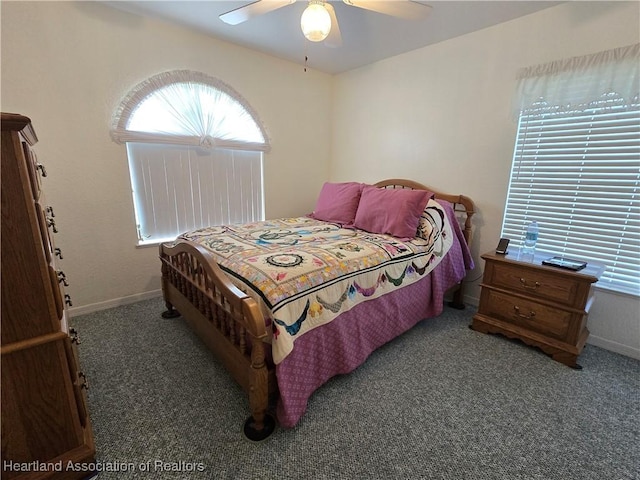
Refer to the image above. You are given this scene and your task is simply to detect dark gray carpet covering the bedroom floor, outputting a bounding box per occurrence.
[71,299,640,480]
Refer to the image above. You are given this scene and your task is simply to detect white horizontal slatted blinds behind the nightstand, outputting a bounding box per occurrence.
[502,93,640,295]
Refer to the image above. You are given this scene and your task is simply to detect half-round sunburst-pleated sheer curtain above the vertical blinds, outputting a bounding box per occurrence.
[111,70,269,151]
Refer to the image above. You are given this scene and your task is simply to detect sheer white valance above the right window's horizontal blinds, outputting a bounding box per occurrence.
[514,44,640,118]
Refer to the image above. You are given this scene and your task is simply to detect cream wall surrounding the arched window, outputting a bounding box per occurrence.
[2,2,332,312]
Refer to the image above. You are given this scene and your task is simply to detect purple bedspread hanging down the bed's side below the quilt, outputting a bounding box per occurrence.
[276,201,473,428]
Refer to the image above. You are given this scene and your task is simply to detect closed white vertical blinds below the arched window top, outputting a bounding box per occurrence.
[127,142,264,245]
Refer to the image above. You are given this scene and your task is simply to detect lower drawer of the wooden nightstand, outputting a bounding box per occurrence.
[479,288,574,340]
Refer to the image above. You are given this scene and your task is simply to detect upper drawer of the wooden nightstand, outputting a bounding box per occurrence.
[484,263,591,305]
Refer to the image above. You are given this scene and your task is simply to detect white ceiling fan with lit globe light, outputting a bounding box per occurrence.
[220,0,431,47]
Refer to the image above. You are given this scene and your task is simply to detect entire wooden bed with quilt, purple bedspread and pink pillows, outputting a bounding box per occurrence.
[160,179,474,441]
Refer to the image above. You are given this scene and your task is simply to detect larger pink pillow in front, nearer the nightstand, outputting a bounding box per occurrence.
[354,186,433,239]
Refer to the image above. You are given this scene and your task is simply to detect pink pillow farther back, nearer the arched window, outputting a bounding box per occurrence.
[309,182,364,225]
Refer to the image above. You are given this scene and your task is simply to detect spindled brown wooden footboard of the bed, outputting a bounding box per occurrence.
[160,240,277,440]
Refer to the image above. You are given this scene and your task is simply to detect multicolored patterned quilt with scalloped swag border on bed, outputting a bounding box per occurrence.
[180,200,453,364]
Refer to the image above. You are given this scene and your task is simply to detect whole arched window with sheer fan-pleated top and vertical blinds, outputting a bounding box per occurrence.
[111,70,269,244]
